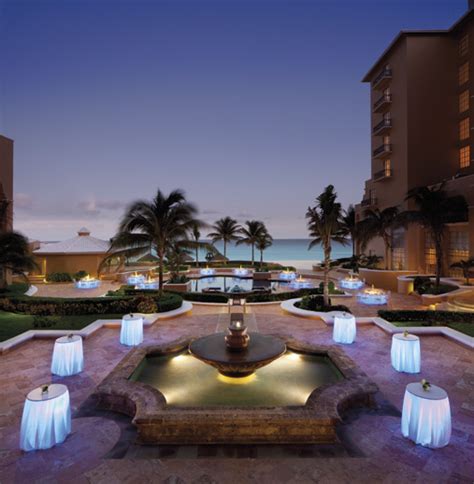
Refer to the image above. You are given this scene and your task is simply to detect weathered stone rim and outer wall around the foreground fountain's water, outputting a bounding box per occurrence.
[93,334,378,444]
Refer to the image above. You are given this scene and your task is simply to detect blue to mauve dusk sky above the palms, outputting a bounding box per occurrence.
[0,0,467,240]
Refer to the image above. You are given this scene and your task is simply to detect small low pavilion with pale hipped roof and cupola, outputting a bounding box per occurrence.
[32,227,110,278]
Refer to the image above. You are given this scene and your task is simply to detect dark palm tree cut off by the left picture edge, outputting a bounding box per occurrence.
[0,184,38,289]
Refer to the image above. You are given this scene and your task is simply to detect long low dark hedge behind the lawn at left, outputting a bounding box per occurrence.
[0,293,183,316]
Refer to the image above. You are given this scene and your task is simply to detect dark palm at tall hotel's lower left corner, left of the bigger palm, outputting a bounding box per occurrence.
[357,207,400,270]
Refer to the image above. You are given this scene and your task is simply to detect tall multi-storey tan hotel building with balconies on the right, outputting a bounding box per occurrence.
[356,1,474,275]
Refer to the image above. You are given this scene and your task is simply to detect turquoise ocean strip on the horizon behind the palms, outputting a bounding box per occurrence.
[199,239,352,269]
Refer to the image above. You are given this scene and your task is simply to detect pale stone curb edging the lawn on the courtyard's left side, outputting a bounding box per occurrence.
[0,301,193,354]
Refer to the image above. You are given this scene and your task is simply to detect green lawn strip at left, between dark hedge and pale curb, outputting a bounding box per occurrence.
[0,311,122,341]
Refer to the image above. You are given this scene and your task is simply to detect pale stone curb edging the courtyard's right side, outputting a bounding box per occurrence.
[280,298,474,349]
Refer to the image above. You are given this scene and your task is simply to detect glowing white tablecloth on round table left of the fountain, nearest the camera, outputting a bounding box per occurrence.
[20,383,71,452]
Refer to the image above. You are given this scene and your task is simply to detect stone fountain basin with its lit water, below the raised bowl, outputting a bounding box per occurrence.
[94,337,377,444]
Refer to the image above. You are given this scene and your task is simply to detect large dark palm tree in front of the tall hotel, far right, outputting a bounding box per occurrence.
[401,183,467,288]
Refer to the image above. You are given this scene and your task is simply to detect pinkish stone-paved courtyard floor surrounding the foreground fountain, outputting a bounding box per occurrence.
[0,304,474,483]
